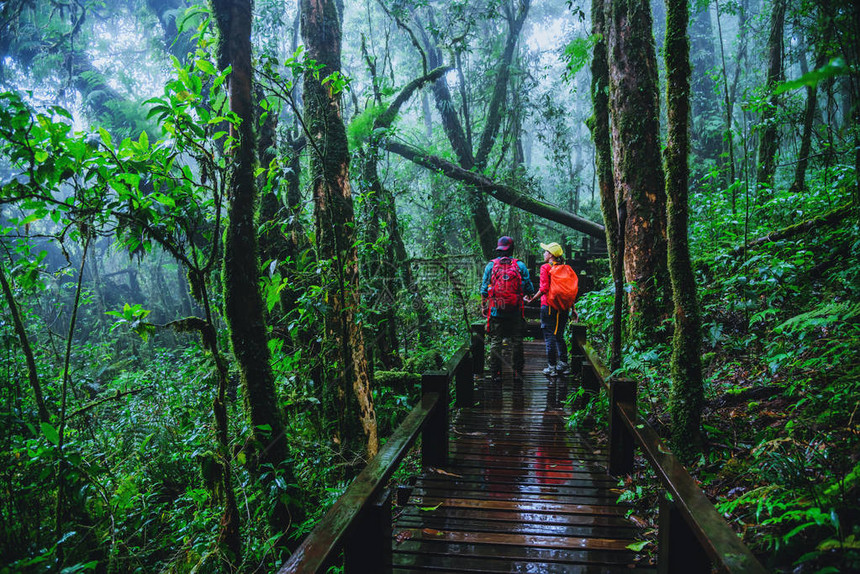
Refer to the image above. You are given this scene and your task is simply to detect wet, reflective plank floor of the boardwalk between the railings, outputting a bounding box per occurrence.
[392,341,655,574]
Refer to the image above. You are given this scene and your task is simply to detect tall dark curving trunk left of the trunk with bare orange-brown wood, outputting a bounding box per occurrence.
[212,0,300,552]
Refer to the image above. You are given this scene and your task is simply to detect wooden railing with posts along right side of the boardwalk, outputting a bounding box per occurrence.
[571,325,766,574]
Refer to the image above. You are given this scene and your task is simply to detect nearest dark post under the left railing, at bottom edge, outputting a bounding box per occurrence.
[343,489,392,574]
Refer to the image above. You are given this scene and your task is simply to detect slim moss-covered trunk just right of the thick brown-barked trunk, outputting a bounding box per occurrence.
[665,0,704,458]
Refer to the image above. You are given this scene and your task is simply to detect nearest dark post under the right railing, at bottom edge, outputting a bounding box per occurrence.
[657,493,711,574]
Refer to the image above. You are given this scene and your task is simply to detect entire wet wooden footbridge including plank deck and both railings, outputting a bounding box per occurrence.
[279,325,765,574]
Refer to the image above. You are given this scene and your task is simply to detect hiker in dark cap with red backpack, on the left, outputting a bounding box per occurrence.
[481,236,535,382]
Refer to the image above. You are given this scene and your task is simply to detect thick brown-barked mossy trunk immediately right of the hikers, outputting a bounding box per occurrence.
[606,0,668,332]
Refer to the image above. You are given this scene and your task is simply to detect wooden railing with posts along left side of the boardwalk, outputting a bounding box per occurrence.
[278,345,474,574]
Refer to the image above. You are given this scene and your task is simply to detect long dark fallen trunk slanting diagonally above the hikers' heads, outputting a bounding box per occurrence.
[382,140,606,239]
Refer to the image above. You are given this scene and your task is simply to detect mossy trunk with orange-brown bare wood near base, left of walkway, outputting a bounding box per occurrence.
[301,0,379,457]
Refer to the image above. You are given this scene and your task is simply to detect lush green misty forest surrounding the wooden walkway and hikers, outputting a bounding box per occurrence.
[0,0,860,573]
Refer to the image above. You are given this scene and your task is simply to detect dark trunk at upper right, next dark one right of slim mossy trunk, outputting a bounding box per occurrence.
[756,0,786,205]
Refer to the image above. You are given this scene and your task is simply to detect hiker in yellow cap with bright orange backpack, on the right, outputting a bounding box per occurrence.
[525,243,579,376]
